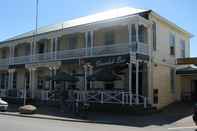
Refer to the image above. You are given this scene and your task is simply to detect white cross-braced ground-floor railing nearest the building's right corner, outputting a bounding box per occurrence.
[70,91,147,108]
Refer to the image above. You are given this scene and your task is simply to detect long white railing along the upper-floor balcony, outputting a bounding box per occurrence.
[0,43,149,67]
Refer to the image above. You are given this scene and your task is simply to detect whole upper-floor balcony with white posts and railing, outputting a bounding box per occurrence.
[0,16,150,67]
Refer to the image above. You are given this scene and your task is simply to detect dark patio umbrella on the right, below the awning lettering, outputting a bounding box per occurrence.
[87,68,121,81]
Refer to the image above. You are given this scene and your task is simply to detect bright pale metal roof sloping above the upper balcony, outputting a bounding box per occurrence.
[5,7,147,41]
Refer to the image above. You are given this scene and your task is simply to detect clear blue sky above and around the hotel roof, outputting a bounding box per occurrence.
[0,0,197,56]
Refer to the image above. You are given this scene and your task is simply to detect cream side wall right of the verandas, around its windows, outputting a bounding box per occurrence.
[150,15,190,109]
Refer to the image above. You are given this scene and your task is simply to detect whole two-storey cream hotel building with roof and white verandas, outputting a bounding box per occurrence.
[0,8,192,109]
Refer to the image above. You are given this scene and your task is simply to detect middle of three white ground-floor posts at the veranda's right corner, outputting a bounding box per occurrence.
[135,60,139,104]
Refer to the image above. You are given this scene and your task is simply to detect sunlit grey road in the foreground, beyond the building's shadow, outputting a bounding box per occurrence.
[0,115,174,131]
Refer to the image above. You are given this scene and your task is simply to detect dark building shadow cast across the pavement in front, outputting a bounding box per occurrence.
[8,102,192,127]
